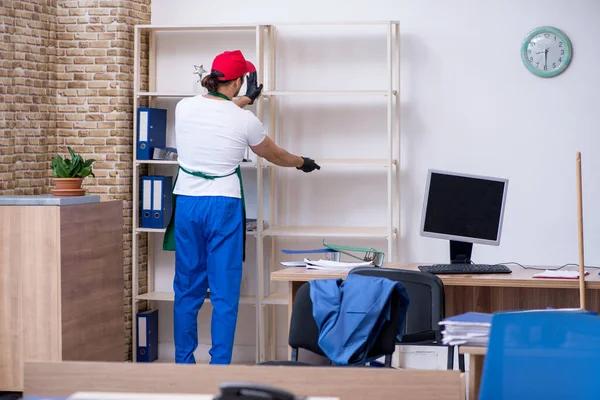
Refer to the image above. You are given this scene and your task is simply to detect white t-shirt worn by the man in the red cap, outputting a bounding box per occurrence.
[174,95,266,198]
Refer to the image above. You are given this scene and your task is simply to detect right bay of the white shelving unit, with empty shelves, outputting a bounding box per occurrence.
[257,21,400,361]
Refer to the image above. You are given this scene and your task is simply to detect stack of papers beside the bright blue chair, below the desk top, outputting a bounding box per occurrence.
[440,312,492,346]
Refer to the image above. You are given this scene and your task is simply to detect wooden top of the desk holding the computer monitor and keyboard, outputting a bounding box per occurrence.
[271,263,600,289]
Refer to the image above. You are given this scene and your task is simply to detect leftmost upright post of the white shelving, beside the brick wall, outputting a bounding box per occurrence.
[131,26,140,362]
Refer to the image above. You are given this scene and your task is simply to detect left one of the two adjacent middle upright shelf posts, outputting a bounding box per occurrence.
[256,25,264,362]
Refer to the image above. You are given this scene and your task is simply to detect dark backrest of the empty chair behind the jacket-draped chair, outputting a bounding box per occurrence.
[350,267,445,335]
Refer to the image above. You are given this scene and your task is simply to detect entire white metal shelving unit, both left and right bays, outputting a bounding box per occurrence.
[132,21,400,361]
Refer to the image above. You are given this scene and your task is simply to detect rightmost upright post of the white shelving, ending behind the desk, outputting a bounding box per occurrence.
[387,21,395,260]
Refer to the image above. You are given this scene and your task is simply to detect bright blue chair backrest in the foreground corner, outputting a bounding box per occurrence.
[479,310,600,400]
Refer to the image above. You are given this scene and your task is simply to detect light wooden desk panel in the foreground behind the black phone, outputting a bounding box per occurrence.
[24,361,465,400]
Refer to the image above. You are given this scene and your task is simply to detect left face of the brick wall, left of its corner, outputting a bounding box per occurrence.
[0,0,56,194]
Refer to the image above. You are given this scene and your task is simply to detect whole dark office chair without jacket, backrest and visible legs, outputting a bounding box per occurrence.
[350,267,454,372]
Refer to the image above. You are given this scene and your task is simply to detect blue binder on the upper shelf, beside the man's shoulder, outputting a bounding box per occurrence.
[137,107,167,160]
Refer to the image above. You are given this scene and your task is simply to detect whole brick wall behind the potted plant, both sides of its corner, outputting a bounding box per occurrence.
[0,0,150,359]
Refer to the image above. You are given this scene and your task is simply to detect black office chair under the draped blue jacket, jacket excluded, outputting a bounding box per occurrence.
[258,282,401,368]
